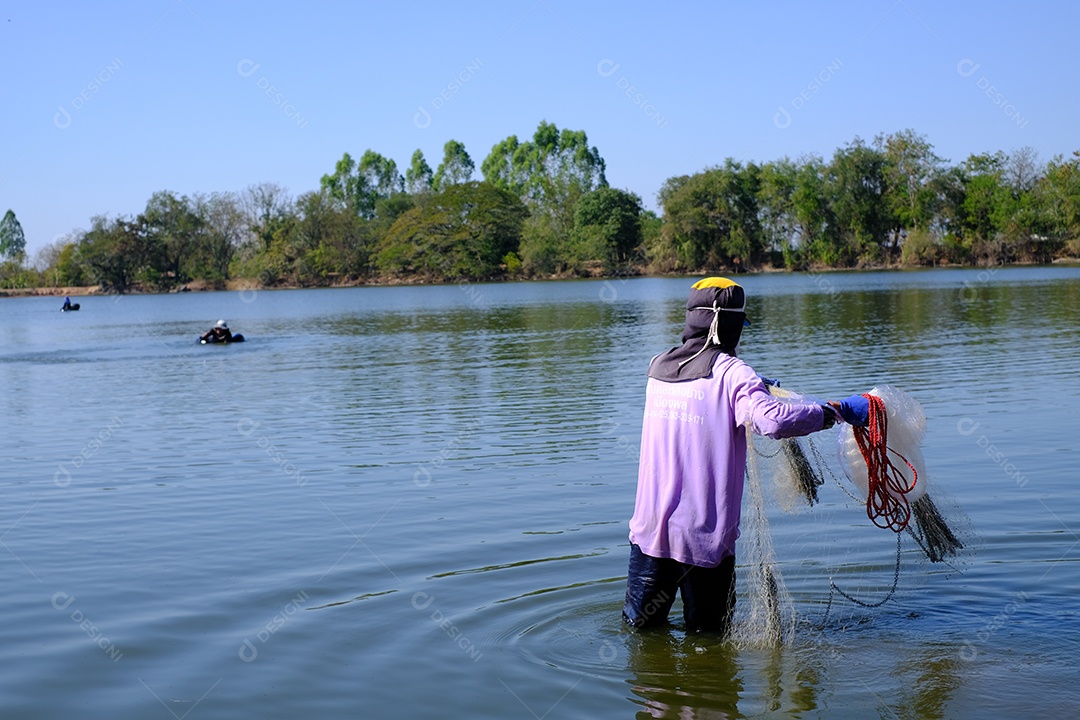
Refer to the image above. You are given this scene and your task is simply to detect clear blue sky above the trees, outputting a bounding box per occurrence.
[0,0,1080,256]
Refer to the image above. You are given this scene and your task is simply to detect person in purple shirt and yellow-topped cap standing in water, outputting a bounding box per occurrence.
[622,277,867,635]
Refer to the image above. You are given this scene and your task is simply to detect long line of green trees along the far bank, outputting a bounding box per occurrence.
[0,122,1080,293]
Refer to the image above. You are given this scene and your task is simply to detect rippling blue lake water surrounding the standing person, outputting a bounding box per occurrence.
[0,268,1080,720]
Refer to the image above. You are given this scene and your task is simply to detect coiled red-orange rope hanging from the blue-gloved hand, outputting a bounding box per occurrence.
[852,394,919,532]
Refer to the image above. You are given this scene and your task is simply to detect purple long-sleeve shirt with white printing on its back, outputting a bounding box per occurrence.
[630,354,824,568]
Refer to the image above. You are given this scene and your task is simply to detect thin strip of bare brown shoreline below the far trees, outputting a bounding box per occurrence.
[0,258,1080,298]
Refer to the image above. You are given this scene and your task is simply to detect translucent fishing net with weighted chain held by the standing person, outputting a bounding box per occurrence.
[732,385,974,647]
